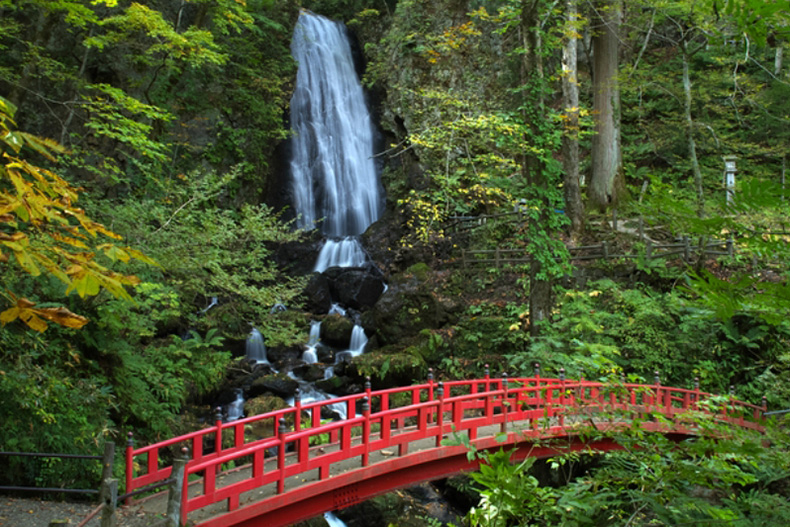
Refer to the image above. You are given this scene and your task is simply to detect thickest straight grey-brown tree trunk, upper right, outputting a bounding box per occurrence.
[589,0,623,209]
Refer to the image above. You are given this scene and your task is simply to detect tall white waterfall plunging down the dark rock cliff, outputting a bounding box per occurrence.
[290,10,383,271]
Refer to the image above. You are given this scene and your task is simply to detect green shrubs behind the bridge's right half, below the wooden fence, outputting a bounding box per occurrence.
[504,280,790,407]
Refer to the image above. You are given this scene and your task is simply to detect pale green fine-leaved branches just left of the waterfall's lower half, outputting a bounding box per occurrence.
[94,168,305,344]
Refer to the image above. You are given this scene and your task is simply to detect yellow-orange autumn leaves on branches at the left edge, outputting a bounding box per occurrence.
[0,97,154,331]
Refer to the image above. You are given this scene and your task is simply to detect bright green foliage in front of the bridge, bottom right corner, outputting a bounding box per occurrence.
[468,414,790,527]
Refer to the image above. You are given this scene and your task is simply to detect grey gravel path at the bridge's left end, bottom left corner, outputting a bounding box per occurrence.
[0,496,164,527]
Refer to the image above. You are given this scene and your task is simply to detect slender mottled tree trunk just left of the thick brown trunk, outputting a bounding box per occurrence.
[562,0,584,241]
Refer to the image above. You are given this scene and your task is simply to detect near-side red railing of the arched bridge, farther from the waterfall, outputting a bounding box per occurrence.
[166,378,765,520]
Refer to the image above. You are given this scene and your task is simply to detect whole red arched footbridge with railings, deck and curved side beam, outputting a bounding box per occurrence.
[126,375,765,527]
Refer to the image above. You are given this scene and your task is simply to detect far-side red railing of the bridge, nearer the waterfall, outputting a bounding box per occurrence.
[125,374,559,503]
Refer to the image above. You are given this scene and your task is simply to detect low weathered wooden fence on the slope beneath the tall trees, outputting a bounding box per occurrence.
[461,236,735,269]
